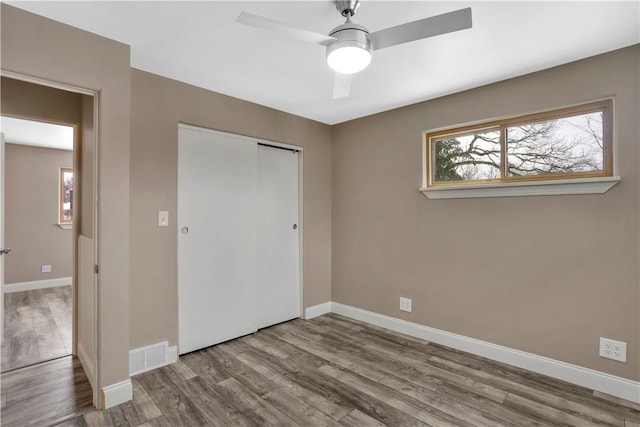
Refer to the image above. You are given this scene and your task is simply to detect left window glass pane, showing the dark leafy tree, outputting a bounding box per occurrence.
[432,129,500,182]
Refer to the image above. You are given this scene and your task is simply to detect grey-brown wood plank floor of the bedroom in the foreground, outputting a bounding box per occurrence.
[3,314,640,427]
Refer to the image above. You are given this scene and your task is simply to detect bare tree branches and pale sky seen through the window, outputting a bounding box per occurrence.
[430,102,606,187]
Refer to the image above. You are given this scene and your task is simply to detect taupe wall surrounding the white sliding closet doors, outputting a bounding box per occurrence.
[130,69,331,348]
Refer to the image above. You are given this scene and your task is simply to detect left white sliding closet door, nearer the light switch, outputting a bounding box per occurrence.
[177,125,258,354]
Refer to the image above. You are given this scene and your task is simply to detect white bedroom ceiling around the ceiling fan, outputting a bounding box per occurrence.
[8,0,640,124]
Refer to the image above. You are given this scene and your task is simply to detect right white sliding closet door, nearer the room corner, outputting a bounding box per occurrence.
[256,145,301,328]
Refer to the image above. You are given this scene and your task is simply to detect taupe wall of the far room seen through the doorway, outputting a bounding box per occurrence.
[4,145,73,284]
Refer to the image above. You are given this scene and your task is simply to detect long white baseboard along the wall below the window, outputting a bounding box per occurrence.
[330,302,640,403]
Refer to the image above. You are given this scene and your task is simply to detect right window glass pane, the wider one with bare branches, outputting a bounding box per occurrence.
[506,112,604,177]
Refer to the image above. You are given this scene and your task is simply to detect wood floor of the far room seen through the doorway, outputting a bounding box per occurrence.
[2,286,72,372]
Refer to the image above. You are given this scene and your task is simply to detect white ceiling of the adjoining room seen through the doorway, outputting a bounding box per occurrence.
[0,116,73,150]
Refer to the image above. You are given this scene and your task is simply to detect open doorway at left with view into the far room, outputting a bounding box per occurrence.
[1,116,77,373]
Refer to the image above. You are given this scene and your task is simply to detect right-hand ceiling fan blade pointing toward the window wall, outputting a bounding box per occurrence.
[369,7,471,50]
